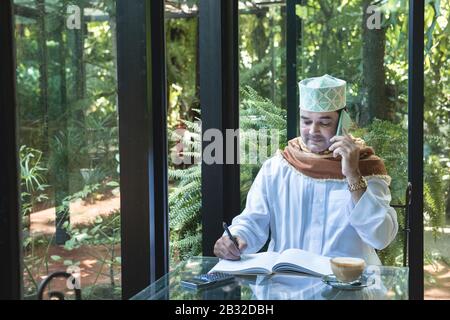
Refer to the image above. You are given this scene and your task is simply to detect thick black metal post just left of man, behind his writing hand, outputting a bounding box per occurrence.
[199,0,240,256]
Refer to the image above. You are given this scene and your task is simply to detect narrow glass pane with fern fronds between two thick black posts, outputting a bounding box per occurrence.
[165,0,202,268]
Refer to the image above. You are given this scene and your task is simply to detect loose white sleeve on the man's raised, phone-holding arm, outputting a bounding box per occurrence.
[347,177,398,250]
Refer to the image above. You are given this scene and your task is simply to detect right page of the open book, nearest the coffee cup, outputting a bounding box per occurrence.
[274,249,333,276]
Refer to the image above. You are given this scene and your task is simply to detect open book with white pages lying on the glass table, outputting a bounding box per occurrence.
[209,249,333,276]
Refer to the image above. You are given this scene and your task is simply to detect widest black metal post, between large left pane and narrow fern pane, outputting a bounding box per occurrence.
[117,0,169,299]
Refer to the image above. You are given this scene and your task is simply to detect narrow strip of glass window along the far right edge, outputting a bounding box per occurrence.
[424,0,450,299]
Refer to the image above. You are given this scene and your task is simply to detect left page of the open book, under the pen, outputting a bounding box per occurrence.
[209,252,280,274]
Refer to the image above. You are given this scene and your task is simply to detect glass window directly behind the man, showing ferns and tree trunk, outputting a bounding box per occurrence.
[240,0,408,265]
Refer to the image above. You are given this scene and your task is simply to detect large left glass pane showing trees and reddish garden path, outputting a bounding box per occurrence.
[14,0,121,299]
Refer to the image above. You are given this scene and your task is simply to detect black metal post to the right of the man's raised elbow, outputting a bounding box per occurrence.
[408,0,425,300]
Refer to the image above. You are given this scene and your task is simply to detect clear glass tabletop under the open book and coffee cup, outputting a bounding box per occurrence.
[132,257,408,300]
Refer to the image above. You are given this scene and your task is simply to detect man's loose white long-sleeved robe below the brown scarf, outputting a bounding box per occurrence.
[230,153,398,265]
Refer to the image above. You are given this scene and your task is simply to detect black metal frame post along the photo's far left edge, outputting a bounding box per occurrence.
[0,0,22,300]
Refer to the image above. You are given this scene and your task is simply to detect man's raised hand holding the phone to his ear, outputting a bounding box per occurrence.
[329,133,361,180]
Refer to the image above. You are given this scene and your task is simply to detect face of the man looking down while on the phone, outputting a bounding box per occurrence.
[300,110,339,153]
